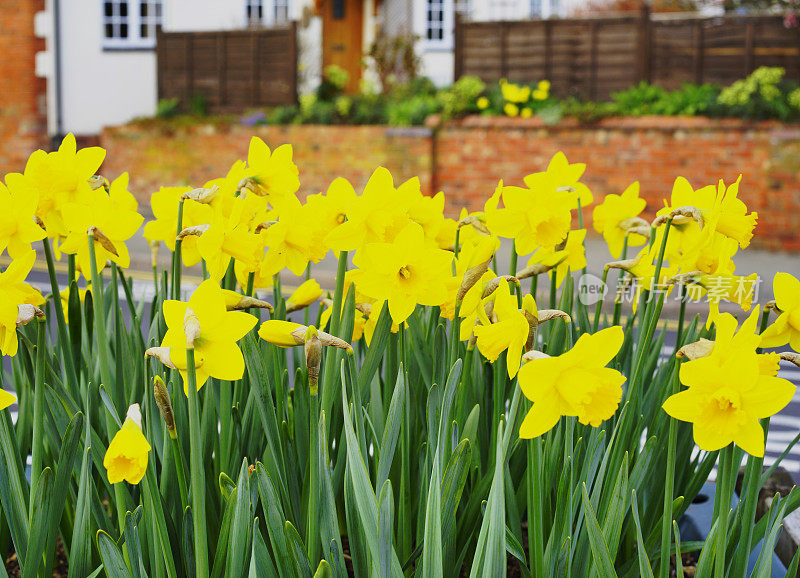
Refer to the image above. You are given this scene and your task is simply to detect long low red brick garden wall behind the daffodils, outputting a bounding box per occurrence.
[101,117,800,250]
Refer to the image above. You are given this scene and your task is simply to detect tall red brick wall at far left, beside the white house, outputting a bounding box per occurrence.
[0,0,47,175]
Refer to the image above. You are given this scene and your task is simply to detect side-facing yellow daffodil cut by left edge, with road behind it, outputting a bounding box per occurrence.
[0,251,44,356]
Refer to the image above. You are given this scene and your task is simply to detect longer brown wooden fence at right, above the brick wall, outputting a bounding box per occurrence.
[455,10,800,99]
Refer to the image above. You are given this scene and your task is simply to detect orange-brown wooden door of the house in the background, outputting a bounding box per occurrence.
[320,0,364,92]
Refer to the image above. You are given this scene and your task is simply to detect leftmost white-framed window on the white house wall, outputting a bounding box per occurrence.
[102,0,163,49]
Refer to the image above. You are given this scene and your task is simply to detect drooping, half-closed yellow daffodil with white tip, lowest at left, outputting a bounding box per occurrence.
[103,403,150,484]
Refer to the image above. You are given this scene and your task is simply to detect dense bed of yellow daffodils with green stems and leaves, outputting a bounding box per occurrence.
[0,134,800,578]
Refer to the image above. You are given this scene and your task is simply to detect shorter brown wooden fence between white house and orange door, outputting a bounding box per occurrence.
[156,23,297,113]
